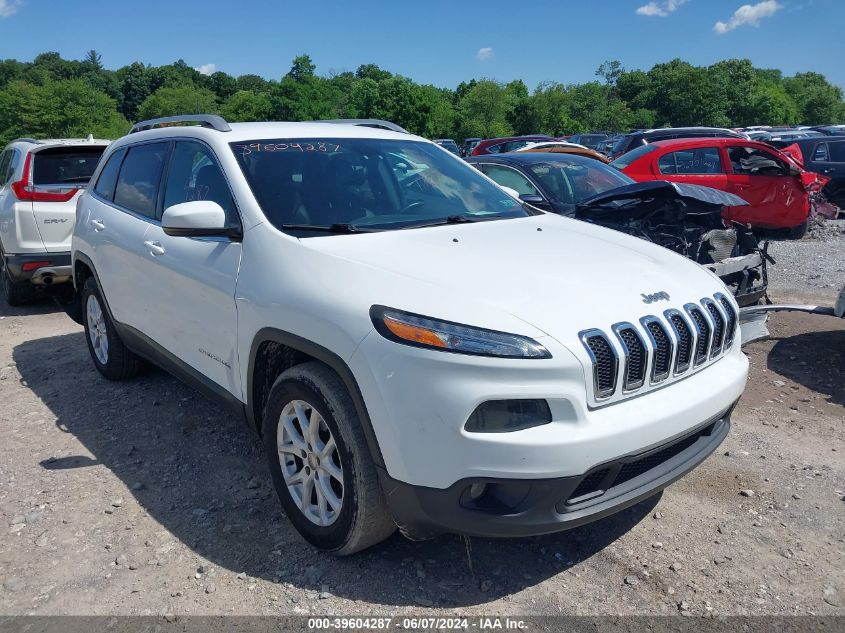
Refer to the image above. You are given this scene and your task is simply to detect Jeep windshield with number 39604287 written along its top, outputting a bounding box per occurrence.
[231,138,531,232]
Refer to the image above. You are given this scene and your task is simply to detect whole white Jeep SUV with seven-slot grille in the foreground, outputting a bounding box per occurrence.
[73,115,748,554]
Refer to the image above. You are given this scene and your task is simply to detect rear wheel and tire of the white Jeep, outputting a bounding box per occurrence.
[80,277,141,380]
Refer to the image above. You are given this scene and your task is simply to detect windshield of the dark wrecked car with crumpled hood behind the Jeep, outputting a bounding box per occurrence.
[529,155,634,204]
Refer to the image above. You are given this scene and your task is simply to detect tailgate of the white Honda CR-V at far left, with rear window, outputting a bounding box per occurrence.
[30,145,105,253]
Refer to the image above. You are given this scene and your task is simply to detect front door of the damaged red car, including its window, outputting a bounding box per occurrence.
[723,145,810,229]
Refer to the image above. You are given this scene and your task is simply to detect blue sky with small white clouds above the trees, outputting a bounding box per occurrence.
[0,0,845,89]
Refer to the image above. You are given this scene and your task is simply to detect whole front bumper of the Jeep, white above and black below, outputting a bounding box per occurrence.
[350,332,748,536]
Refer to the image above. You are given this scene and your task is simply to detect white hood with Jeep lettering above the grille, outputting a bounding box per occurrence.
[300,214,727,343]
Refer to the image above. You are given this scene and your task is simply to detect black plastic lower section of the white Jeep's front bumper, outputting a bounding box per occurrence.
[382,407,733,539]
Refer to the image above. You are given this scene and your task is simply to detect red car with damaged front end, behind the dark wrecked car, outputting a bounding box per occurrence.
[611,138,824,239]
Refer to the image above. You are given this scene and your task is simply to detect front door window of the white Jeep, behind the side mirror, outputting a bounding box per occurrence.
[164,141,238,226]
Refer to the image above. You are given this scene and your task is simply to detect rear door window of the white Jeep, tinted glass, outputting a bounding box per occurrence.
[114,143,167,218]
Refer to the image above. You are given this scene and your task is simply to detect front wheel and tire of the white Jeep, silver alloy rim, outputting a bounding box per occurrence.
[263,361,396,556]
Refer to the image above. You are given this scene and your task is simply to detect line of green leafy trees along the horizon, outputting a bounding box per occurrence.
[0,51,845,143]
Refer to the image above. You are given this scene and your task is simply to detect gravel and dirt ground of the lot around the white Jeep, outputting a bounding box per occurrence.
[0,241,845,615]
